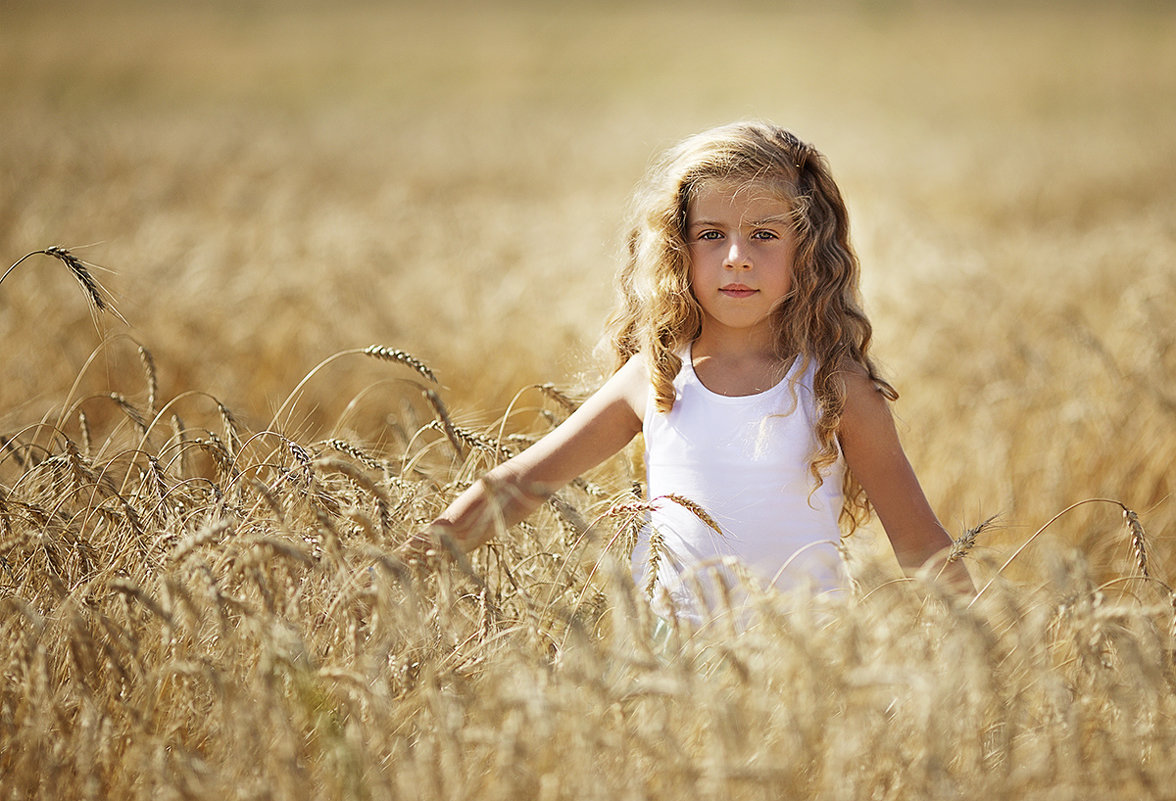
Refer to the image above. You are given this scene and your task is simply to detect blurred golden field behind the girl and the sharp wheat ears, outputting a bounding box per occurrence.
[0,2,1176,569]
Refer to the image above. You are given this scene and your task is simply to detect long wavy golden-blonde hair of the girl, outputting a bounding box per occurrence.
[607,122,897,532]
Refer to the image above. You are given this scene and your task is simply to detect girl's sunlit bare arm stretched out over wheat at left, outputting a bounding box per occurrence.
[409,356,649,550]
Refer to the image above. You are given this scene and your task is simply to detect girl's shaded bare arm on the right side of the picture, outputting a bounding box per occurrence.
[838,371,973,589]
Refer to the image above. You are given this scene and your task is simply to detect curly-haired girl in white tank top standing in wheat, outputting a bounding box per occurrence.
[414,122,967,619]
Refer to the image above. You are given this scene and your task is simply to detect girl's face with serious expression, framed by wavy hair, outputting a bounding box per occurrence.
[686,182,796,339]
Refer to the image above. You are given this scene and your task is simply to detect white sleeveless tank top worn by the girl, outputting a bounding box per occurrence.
[633,352,848,622]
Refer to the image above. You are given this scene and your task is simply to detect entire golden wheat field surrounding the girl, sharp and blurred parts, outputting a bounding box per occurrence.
[0,0,1176,801]
